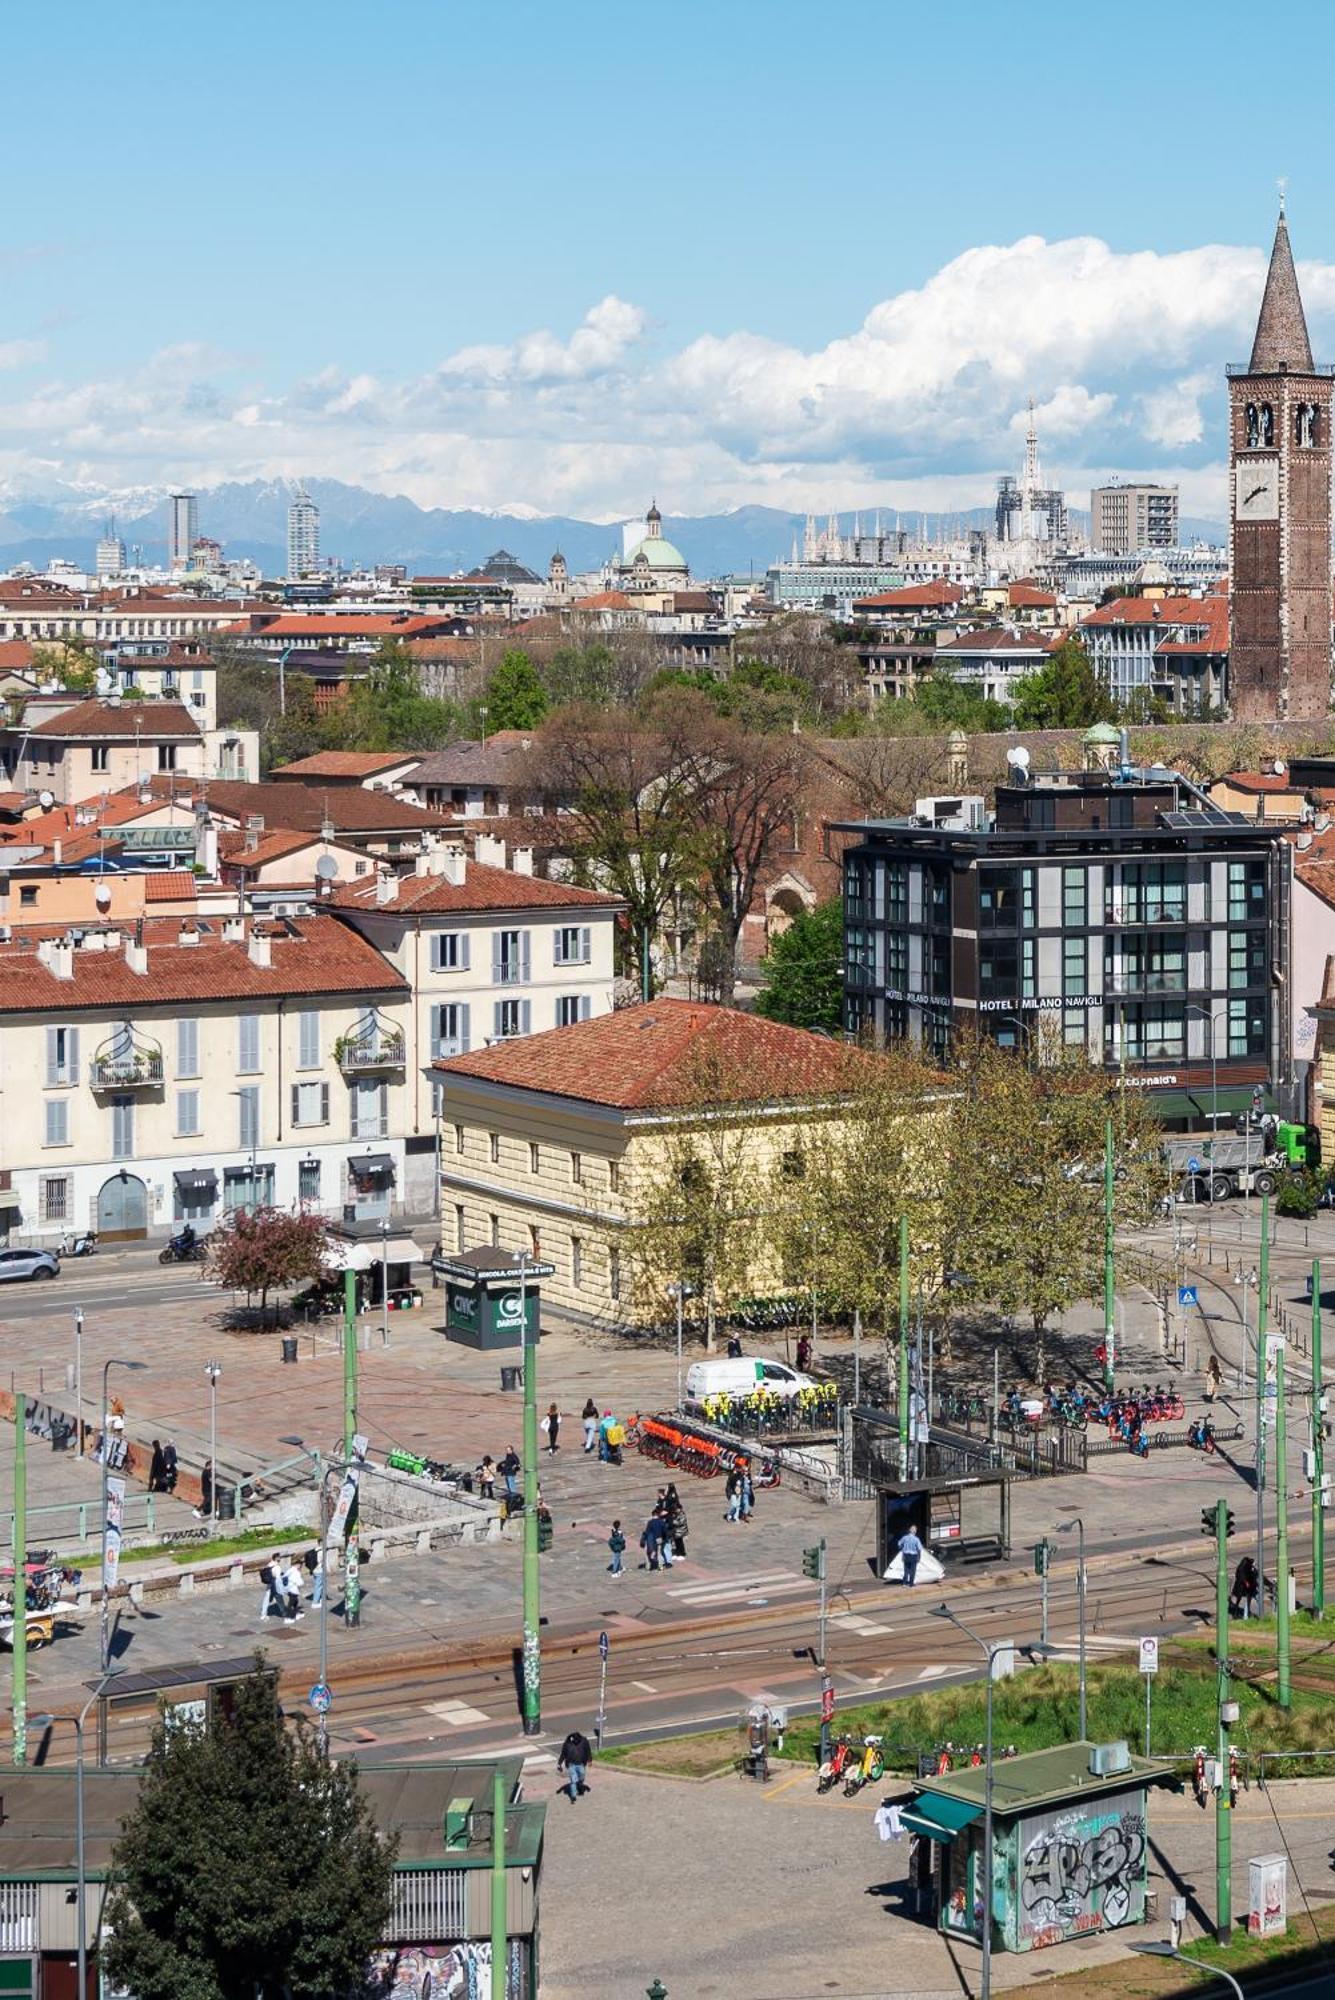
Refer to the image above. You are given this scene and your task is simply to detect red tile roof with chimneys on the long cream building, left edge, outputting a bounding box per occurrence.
[0,916,408,1014]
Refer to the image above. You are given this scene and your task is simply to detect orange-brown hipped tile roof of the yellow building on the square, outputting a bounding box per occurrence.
[436,1000,857,1110]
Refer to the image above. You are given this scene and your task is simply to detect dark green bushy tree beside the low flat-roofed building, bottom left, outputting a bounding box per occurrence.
[104,1658,398,2000]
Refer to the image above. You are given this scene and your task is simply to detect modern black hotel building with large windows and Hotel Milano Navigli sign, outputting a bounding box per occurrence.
[835,744,1291,1130]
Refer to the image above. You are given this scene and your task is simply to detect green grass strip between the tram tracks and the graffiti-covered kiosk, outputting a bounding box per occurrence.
[787,1662,1335,1778]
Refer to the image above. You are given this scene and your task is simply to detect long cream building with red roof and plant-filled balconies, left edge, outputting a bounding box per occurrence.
[0,916,412,1244]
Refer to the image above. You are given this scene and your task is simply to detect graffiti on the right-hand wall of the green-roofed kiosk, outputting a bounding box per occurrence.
[1019,1810,1145,1944]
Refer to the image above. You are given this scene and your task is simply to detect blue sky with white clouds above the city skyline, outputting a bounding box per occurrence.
[0,0,1335,516]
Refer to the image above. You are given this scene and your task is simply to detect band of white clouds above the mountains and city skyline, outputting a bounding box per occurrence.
[0,236,1335,518]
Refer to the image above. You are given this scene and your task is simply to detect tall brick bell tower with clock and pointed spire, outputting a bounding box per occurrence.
[1229,204,1331,722]
